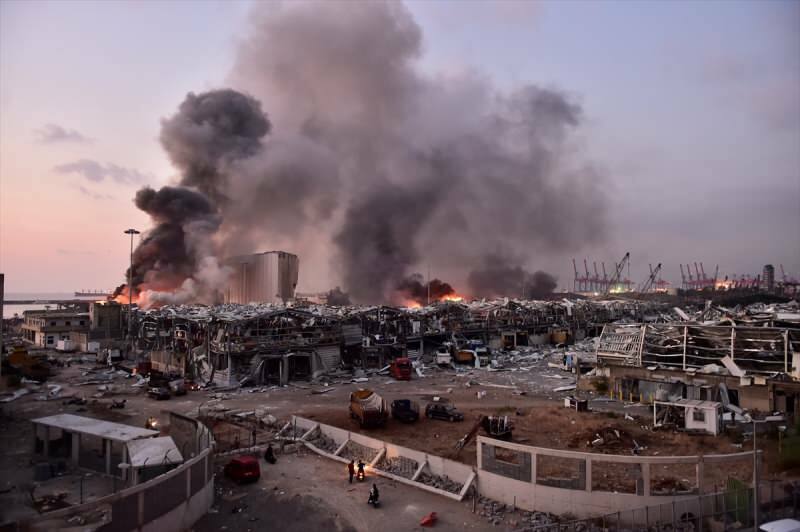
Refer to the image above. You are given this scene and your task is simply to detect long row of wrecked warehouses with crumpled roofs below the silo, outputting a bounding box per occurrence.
[137,300,676,385]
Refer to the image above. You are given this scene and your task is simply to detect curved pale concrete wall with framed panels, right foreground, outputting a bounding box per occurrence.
[477,436,752,518]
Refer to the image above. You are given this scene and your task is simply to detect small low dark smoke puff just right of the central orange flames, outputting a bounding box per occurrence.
[467,255,557,299]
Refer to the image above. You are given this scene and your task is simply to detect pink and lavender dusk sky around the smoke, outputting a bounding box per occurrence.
[0,0,800,292]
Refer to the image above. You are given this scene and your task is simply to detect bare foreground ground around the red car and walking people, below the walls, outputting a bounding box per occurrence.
[194,451,500,532]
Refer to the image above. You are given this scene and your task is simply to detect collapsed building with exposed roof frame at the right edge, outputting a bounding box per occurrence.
[596,316,800,419]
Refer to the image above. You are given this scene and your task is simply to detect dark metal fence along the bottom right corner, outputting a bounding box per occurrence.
[529,481,800,532]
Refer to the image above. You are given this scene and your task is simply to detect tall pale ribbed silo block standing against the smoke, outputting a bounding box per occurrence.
[225,251,300,304]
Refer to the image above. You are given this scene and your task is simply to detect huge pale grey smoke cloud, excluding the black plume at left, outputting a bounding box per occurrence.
[231,2,605,302]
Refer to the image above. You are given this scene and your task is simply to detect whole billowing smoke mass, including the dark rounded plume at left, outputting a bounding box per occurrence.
[119,1,605,303]
